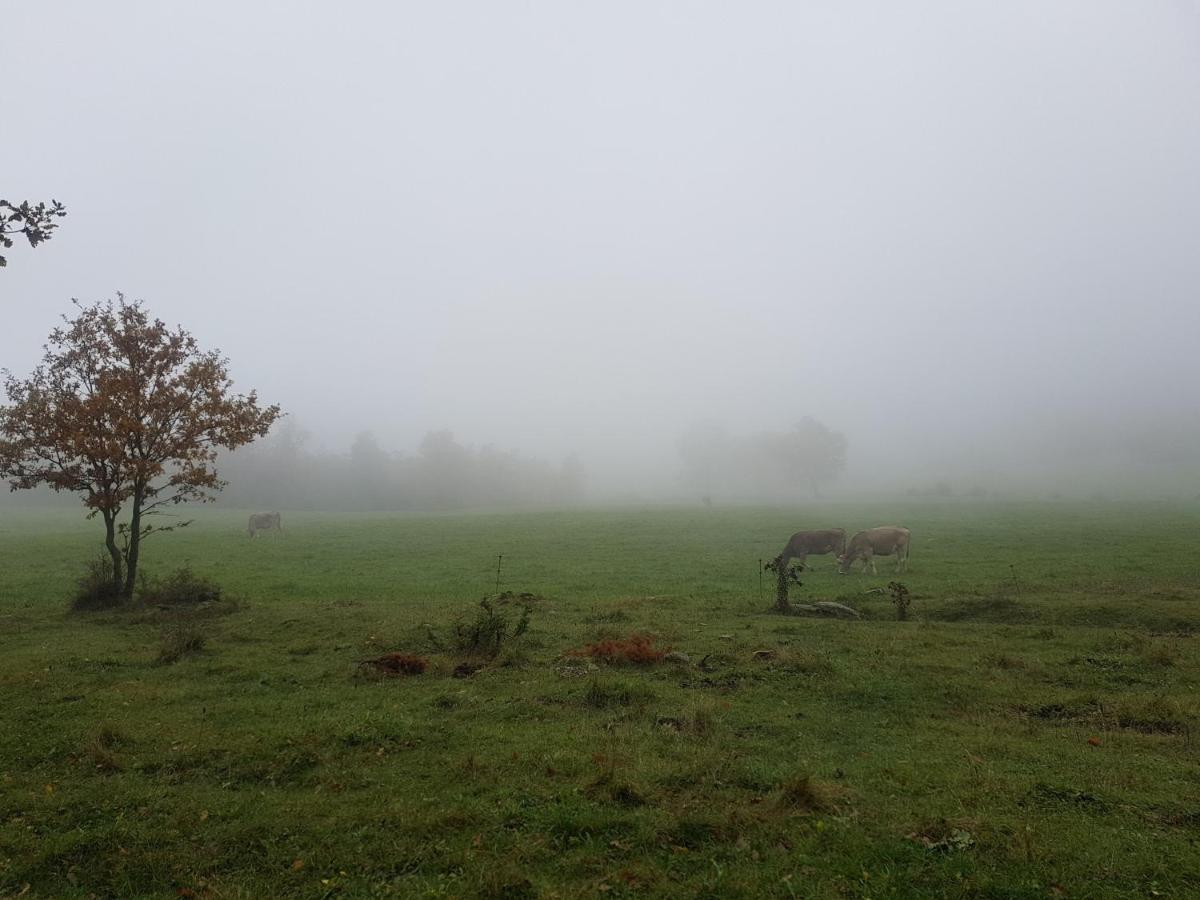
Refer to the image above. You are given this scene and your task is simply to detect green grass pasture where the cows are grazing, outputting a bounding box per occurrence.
[0,503,1200,898]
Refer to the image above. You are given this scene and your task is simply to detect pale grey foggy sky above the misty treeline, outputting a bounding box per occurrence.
[0,0,1200,487]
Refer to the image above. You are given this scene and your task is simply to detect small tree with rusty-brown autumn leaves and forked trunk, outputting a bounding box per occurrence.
[0,294,280,598]
